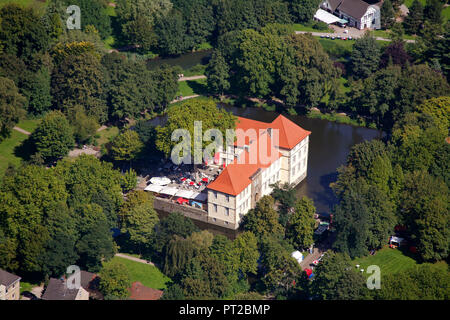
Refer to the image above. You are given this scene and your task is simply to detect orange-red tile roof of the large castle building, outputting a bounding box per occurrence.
[208,115,311,196]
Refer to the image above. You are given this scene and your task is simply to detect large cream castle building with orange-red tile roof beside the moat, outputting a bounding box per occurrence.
[207,115,311,229]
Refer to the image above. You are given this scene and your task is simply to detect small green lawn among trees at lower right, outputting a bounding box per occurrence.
[353,247,417,274]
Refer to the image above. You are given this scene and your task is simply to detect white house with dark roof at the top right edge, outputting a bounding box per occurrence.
[320,0,382,30]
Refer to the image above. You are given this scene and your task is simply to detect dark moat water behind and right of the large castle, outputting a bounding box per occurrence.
[151,106,383,235]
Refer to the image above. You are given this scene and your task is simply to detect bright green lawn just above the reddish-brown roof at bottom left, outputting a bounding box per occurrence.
[113,257,171,290]
